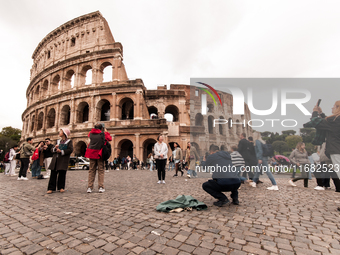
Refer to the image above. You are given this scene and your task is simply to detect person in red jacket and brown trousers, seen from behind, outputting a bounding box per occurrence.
[85,123,112,193]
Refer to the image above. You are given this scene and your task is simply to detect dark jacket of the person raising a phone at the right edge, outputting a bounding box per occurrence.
[312,112,340,155]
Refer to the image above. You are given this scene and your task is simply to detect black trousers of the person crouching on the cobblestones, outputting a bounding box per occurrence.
[202,180,241,201]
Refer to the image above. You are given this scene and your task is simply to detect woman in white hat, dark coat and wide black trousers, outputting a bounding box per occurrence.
[47,128,73,194]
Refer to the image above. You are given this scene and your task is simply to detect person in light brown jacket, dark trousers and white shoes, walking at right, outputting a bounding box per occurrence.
[289,142,310,188]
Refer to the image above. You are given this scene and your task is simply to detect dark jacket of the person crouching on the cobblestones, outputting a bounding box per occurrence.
[204,151,241,185]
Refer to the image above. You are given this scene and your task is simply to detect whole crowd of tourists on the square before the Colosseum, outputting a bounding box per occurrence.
[4,101,340,206]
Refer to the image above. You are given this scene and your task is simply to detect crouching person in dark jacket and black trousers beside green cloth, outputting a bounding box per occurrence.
[202,145,241,207]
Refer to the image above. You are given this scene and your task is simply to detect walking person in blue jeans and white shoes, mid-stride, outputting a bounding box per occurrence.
[250,138,279,190]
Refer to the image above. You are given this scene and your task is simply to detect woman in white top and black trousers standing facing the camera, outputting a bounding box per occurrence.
[154,135,168,184]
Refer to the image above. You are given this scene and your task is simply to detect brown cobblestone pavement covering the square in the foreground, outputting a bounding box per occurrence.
[0,170,340,255]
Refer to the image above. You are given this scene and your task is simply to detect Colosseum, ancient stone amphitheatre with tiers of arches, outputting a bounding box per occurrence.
[22,11,252,160]
